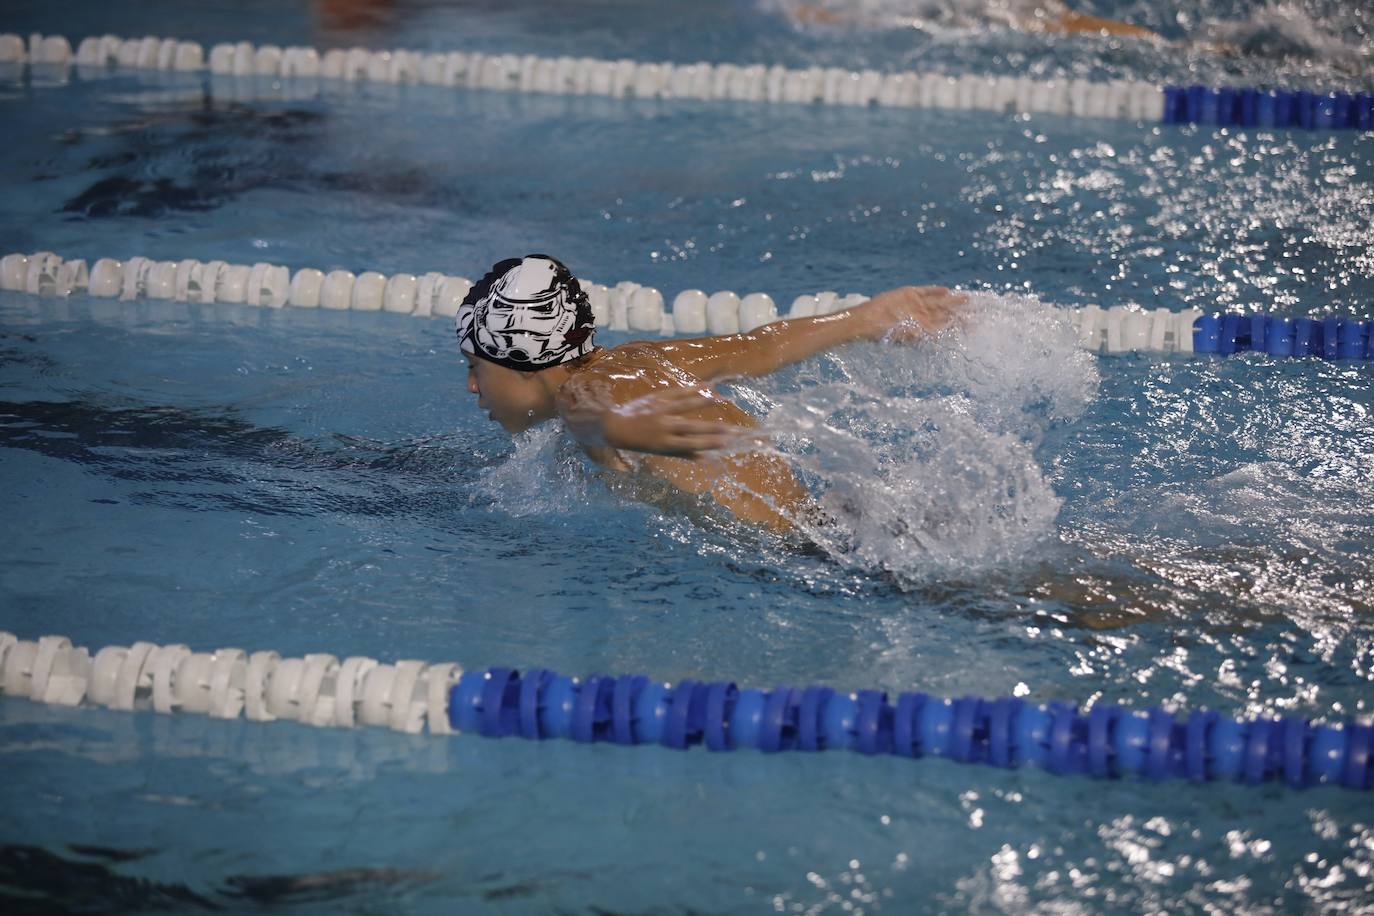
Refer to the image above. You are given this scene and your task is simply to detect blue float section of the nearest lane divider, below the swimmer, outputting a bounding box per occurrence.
[448,667,1374,790]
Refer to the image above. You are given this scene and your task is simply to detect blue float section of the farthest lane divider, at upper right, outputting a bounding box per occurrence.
[1161,85,1374,130]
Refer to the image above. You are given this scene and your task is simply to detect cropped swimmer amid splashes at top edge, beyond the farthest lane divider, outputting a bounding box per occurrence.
[775,0,1160,40]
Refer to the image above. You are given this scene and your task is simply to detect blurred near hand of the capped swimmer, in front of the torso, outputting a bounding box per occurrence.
[563,389,758,459]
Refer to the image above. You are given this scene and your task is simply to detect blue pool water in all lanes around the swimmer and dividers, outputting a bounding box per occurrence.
[0,3,1374,913]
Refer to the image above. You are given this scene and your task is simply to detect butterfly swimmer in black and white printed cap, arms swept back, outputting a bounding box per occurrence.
[458,254,965,529]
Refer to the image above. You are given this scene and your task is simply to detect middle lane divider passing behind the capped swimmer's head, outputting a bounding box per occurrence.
[0,251,1374,360]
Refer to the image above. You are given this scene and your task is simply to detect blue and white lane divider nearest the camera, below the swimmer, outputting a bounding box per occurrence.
[0,632,1374,791]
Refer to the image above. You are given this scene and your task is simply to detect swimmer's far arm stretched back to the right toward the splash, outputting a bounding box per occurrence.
[657,286,965,383]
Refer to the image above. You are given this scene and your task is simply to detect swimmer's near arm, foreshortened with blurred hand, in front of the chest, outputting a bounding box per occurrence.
[556,369,749,459]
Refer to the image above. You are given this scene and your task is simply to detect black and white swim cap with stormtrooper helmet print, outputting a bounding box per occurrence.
[458,254,596,372]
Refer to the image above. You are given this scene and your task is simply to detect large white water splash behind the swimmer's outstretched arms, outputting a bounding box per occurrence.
[765,294,1098,582]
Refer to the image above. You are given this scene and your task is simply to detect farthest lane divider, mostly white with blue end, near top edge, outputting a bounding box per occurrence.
[0,34,1374,130]
